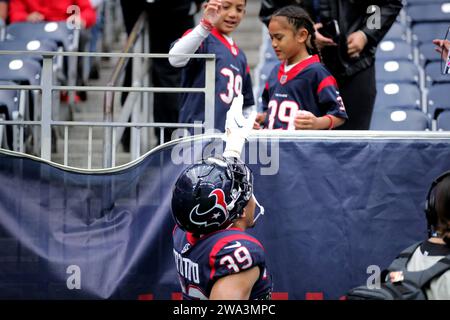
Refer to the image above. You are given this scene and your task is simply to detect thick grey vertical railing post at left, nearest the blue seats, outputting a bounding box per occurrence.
[41,55,53,160]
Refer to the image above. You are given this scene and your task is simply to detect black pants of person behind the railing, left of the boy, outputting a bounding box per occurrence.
[121,0,194,149]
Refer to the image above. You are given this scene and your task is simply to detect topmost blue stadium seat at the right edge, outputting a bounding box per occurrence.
[406,2,450,24]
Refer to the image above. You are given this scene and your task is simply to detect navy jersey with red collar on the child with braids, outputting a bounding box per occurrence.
[262,55,348,130]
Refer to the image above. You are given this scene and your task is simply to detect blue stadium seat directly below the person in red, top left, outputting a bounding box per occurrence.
[6,22,75,51]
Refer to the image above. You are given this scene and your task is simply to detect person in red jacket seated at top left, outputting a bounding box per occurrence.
[9,0,96,28]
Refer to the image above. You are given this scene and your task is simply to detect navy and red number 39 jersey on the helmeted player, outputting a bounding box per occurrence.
[173,227,272,300]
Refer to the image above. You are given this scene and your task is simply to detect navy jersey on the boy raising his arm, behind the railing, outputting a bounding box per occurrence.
[178,29,255,132]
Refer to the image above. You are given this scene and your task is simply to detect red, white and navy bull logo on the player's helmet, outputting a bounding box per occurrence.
[189,189,229,227]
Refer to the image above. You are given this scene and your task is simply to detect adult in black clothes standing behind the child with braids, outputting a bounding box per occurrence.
[260,0,402,130]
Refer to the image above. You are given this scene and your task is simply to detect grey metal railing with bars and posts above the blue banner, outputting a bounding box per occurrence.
[0,51,215,169]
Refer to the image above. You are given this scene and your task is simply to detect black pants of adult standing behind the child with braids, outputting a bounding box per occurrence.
[336,65,377,130]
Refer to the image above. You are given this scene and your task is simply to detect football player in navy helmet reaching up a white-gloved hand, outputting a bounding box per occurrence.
[172,95,272,300]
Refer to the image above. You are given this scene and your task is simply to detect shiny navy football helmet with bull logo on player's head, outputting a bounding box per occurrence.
[172,158,253,234]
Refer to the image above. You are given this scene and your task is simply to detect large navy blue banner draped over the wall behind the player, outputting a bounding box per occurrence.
[0,138,450,299]
